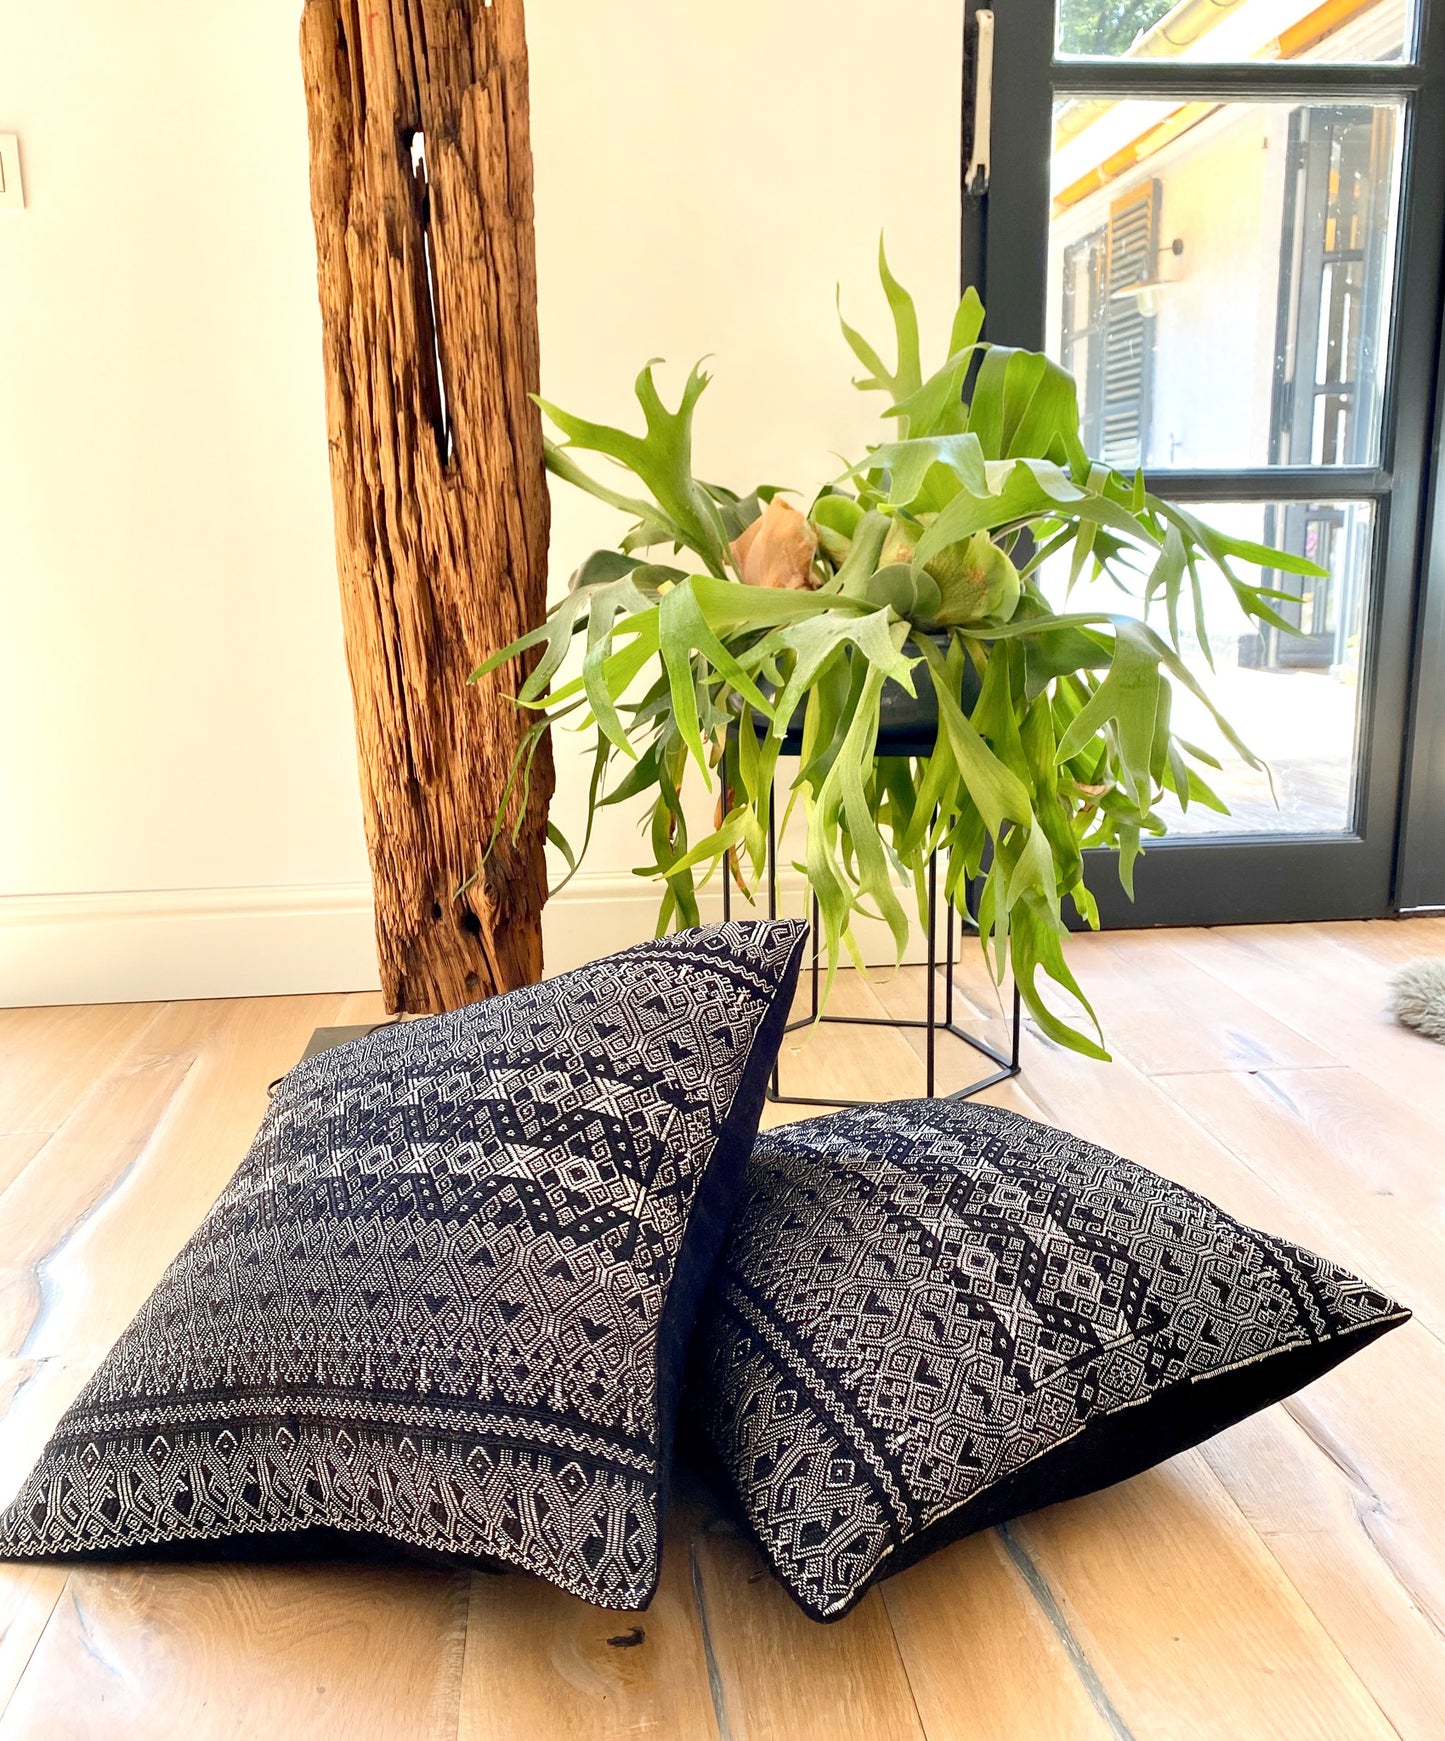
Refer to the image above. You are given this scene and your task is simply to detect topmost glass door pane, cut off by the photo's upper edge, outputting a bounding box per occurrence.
[1057,0,1415,63]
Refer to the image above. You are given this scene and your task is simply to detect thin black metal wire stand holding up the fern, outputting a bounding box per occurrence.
[723,713,1022,1107]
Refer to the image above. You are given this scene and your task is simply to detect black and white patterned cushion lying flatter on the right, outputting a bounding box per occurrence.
[688,1100,1408,1619]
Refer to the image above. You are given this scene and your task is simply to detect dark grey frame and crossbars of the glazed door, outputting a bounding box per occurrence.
[961,0,1445,928]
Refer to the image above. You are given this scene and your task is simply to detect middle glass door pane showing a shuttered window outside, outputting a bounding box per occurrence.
[1048,97,1403,468]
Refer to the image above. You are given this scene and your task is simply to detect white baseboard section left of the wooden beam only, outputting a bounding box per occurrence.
[0,883,378,1008]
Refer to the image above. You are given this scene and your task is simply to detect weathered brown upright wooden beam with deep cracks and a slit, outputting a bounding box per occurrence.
[301,0,552,1012]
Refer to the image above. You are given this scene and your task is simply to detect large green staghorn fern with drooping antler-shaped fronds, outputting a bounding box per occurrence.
[474,249,1320,1057]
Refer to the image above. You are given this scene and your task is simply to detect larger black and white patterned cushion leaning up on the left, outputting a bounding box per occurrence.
[0,923,804,1609]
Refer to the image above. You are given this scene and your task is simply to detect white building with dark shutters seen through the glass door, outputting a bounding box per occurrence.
[1046,0,1407,832]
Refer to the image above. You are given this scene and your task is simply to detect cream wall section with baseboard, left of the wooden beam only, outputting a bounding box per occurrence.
[0,0,373,1003]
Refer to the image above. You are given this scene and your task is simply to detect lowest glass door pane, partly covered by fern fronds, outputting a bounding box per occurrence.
[1041,501,1374,846]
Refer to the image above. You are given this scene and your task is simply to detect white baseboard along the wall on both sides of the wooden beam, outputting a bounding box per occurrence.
[0,872,923,1008]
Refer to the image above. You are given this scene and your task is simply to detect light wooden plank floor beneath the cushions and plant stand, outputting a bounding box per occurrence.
[0,919,1445,1741]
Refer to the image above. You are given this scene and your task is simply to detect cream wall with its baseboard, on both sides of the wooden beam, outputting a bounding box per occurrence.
[0,0,961,1003]
